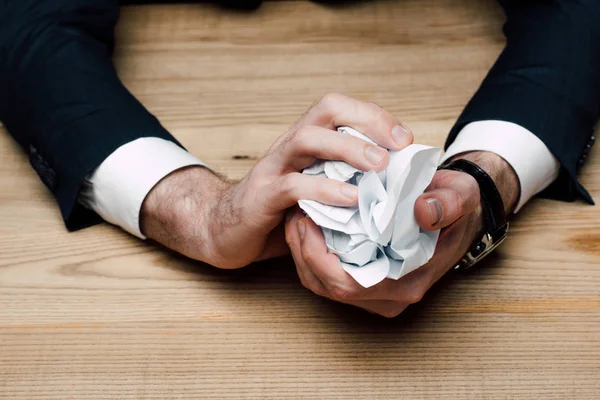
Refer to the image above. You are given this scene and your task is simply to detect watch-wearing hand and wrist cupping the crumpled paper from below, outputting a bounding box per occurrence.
[286,152,519,317]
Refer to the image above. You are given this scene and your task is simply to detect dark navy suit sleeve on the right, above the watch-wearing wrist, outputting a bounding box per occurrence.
[446,0,600,204]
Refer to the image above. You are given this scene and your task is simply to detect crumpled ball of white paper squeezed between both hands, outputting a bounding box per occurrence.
[298,127,441,288]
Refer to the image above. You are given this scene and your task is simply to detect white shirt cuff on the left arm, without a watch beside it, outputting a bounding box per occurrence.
[79,137,206,239]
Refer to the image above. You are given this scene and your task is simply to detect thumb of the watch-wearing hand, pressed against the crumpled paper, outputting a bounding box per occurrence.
[414,170,480,230]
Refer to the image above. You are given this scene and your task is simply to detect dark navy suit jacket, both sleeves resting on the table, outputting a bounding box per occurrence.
[0,0,600,230]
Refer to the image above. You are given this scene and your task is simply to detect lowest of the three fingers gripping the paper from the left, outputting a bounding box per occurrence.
[262,172,358,213]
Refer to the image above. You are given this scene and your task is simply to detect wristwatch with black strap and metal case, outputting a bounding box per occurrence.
[438,159,508,270]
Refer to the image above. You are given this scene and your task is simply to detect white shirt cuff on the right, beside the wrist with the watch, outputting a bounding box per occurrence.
[442,120,560,213]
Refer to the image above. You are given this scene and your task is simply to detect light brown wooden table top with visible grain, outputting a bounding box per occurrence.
[0,0,600,400]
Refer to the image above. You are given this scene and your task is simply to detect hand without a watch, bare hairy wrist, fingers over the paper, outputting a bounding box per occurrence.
[140,93,413,269]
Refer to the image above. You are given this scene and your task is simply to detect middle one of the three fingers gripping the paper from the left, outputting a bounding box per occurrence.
[270,125,390,171]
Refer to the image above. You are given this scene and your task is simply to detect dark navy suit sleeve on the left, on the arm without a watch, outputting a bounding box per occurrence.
[0,0,177,230]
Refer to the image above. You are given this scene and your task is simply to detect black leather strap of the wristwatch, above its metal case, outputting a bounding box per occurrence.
[439,159,507,232]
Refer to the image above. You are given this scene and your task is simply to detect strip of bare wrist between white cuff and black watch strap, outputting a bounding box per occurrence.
[452,151,521,215]
